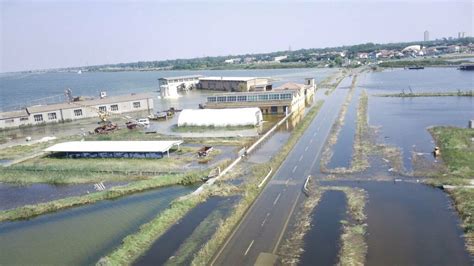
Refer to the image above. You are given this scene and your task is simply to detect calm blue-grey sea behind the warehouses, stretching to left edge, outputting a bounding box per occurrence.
[0,69,337,110]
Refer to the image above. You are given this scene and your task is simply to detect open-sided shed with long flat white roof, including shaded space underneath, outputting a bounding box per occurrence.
[44,140,183,158]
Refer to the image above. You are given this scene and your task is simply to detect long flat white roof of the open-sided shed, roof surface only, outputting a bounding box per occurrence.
[45,140,183,152]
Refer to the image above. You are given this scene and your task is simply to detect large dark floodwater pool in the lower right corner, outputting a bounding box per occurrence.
[321,181,472,265]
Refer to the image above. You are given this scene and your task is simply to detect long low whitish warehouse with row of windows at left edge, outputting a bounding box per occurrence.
[0,94,153,129]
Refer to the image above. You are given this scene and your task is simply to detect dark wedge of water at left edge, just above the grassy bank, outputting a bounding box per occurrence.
[0,182,128,210]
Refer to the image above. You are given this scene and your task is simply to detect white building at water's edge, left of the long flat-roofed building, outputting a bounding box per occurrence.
[158,75,202,98]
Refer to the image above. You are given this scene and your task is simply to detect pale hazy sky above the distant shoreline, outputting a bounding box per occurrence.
[0,0,474,72]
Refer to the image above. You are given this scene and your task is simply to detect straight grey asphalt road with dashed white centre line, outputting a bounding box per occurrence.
[212,77,352,266]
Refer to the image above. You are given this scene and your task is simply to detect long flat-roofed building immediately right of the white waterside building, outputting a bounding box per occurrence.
[198,77,272,92]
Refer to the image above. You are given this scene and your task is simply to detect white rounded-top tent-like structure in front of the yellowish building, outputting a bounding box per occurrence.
[178,107,263,127]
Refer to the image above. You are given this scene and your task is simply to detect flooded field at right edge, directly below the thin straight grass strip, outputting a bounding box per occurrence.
[369,97,474,171]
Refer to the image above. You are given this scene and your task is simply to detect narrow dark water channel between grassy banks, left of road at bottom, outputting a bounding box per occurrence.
[135,197,236,265]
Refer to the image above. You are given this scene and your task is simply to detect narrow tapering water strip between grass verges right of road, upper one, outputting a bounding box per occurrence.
[328,88,361,169]
